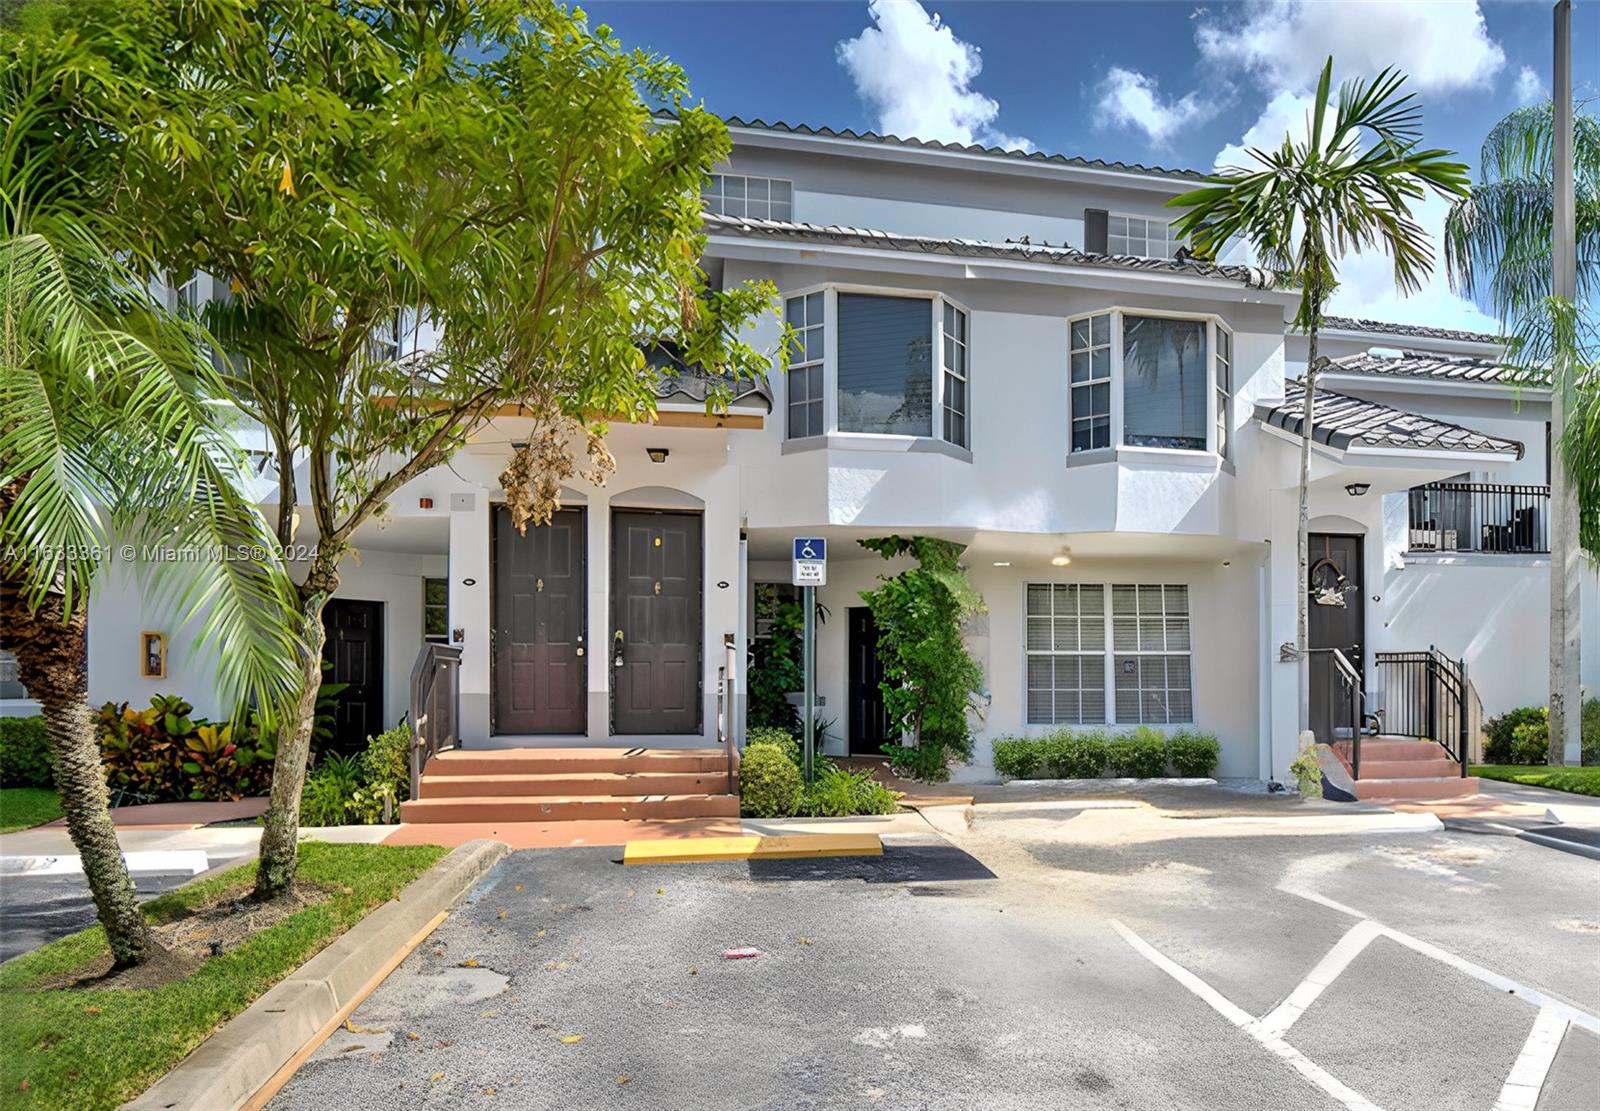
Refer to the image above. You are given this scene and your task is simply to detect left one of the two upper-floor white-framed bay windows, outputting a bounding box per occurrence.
[784,287,971,450]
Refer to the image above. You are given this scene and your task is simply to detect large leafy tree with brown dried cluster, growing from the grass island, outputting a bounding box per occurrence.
[100,0,776,896]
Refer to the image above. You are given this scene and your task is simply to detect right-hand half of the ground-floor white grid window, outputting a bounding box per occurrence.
[1110,584,1194,725]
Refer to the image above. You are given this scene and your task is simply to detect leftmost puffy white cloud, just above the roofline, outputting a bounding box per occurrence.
[837,0,1034,150]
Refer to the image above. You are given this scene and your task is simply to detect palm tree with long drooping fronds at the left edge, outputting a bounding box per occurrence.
[0,204,296,967]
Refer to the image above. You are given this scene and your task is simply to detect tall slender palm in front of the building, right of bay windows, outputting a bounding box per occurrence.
[1168,58,1467,752]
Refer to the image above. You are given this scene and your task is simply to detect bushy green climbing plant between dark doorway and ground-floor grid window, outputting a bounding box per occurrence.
[859,536,984,780]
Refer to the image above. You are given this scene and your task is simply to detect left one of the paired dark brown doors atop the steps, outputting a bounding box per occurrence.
[494,506,589,733]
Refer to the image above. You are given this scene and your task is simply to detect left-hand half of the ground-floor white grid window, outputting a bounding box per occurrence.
[1027,583,1106,725]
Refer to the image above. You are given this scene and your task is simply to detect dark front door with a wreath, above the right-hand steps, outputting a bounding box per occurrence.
[1306,533,1366,744]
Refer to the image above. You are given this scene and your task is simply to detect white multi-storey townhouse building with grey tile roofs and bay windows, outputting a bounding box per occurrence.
[9,118,1595,819]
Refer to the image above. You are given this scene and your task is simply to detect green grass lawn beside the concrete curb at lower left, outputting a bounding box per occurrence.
[0,840,445,1111]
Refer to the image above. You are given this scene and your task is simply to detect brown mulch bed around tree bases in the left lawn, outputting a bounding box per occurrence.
[34,882,333,991]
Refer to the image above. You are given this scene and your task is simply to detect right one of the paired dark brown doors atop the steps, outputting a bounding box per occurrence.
[611,511,701,735]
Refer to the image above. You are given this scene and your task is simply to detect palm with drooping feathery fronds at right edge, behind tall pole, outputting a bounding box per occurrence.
[1445,93,1600,764]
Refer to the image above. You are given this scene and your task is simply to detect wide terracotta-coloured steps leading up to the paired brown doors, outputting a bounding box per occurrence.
[400,748,739,823]
